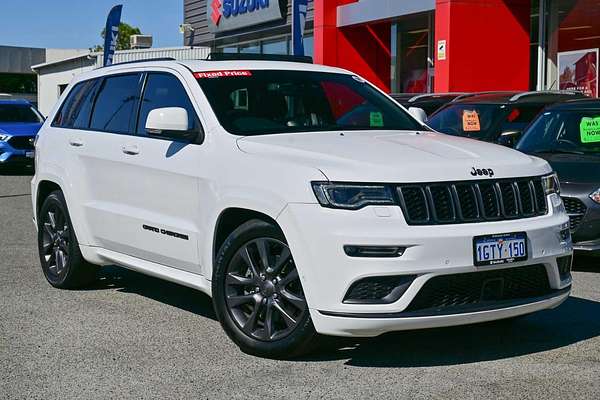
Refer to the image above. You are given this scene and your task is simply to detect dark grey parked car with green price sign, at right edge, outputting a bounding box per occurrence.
[517,99,600,255]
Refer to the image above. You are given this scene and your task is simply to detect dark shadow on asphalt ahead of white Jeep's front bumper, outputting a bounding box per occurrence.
[303,297,600,368]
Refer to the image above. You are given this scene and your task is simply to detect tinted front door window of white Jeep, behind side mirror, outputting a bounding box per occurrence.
[137,73,200,135]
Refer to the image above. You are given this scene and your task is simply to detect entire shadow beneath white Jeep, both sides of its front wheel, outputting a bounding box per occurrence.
[85,266,600,368]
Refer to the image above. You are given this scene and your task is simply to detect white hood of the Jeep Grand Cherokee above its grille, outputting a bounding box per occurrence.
[238,131,551,183]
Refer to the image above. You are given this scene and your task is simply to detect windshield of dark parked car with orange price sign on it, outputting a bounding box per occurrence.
[427,104,505,139]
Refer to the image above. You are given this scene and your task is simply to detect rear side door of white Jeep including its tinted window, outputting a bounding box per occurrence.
[68,73,150,255]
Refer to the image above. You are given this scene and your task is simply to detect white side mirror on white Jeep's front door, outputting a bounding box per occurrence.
[145,107,198,142]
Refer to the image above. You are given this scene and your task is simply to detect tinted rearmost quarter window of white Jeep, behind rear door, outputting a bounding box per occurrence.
[52,80,96,128]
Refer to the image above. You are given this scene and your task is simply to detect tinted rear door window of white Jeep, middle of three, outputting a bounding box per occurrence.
[90,74,141,133]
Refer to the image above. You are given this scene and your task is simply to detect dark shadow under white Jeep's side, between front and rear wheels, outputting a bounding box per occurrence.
[90,266,217,321]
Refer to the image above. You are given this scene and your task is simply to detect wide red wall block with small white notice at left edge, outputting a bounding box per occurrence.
[435,0,531,92]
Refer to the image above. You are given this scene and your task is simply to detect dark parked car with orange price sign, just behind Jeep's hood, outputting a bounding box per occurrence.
[427,91,585,147]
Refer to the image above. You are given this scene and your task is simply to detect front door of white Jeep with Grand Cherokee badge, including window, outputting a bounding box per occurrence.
[96,72,205,273]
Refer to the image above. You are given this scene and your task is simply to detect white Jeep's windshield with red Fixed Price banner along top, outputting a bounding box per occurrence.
[195,70,425,136]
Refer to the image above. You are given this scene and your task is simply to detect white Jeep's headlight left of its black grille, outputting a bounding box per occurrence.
[312,182,395,210]
